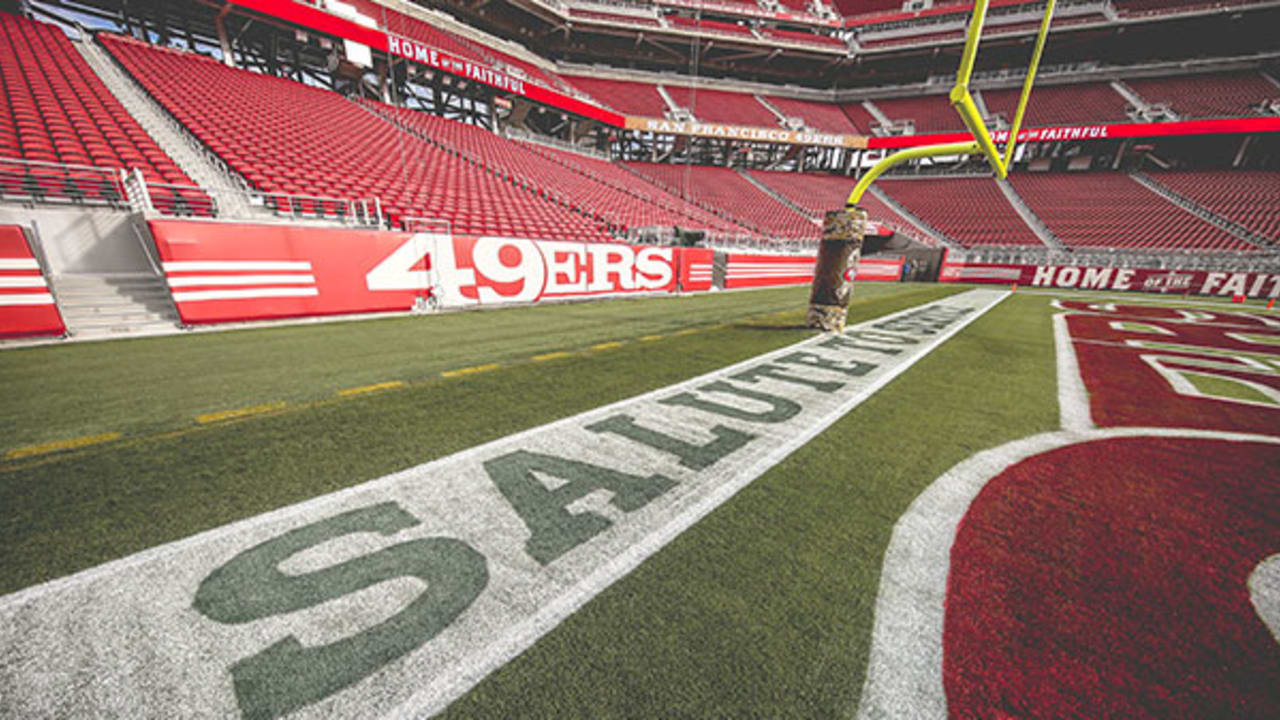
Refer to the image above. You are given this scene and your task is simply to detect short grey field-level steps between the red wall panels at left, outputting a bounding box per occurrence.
[52,273,178,340]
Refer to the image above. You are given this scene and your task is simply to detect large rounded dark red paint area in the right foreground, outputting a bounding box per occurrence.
[943,438,1280,719]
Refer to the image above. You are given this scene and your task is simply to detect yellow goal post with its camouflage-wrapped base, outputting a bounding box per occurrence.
[806,0,1057,332]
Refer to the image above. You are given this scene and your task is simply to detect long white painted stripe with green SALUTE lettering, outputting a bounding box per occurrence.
[0,290,1007,717]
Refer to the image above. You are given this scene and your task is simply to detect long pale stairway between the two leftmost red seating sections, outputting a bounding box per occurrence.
[72,34,251,218]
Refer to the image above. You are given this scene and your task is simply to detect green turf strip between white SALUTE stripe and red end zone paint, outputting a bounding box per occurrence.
[443,288,1059,719]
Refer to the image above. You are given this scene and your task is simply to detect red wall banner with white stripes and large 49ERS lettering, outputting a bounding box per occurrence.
[148,220,696,324]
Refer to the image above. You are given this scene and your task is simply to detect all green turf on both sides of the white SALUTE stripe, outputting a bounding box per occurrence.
[0,284,1057,717]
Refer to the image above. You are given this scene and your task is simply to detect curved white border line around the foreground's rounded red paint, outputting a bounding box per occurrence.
[858,428,1280,720]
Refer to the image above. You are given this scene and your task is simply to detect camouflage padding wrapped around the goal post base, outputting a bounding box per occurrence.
[805,208,867,332]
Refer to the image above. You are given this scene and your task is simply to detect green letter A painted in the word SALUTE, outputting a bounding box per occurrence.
[484,450,676,565]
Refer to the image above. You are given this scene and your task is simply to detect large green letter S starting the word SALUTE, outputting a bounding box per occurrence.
[192,502,489,719]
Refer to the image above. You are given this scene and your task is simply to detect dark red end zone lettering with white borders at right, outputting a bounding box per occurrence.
[859,301,1280,719]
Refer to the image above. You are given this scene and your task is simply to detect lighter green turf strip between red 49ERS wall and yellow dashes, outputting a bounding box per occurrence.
[0,284,923,448]
